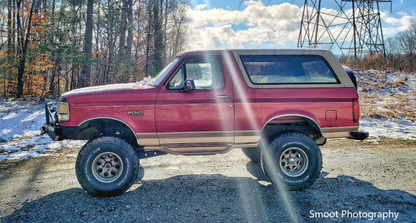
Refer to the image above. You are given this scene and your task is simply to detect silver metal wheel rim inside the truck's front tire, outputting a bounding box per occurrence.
[92,152,123,183]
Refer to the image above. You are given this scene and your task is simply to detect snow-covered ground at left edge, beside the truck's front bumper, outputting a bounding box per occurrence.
[0,99,85,161]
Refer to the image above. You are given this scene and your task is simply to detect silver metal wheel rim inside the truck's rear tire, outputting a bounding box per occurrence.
[279,147,309,177]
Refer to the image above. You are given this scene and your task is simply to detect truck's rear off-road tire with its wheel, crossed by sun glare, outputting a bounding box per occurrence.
[260,132,322,190]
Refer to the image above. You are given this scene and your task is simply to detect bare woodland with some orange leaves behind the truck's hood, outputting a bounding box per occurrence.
[0,0,189,98]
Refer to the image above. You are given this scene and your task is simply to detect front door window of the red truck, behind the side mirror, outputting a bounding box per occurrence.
[168,59,224,90]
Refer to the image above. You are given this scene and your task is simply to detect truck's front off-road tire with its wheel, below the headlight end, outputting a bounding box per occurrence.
[75,136,139,197]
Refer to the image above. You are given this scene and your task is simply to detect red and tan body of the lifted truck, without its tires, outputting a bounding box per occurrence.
[42,49,368,197]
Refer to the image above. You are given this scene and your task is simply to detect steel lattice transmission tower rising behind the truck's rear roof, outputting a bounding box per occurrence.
[298,0,391,58]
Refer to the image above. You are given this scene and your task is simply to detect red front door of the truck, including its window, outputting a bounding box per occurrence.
[155,56,234,145]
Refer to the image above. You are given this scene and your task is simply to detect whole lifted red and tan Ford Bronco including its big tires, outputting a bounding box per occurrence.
[42,49,368,196]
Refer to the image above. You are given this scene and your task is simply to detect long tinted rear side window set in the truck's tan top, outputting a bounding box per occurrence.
[240,55,339,85]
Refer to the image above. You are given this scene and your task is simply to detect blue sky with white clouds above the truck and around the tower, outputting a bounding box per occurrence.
[187,0,416,54]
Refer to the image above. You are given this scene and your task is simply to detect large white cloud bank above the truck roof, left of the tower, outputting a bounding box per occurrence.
[187,1,302,49]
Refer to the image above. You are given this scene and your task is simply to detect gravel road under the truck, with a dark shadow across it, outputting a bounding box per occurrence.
[0,139,416,222]
